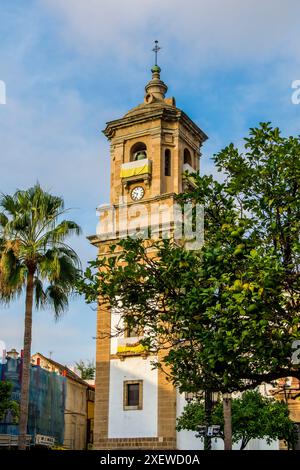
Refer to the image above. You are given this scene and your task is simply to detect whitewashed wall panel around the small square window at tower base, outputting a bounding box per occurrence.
[108,357,157,438]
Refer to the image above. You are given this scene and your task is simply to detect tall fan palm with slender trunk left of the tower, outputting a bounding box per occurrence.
[0,184,80,450]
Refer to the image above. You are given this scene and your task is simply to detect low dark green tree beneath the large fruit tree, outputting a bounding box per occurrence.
[177,390,295,450]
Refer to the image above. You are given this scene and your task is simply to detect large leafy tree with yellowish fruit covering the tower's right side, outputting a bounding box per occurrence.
[78,123,300,448]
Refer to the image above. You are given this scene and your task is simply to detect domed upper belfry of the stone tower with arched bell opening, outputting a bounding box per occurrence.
[104,65,207,204]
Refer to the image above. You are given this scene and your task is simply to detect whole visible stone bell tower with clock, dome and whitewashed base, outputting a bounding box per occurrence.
[89,48,207,449]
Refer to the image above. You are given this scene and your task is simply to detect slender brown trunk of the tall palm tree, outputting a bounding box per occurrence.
[18,269,34,450]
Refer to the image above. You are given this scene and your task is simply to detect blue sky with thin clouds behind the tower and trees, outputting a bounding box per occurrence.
[0,0,300,364]
